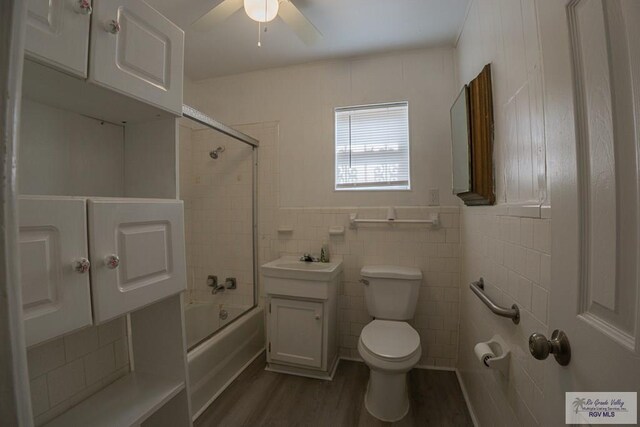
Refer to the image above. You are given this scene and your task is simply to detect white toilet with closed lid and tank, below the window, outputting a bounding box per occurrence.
[358,265,422,422]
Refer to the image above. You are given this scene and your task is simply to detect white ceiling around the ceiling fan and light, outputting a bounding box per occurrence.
[147,0,469,80]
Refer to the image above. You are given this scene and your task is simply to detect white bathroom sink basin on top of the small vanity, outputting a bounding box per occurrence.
[261,256,342,282]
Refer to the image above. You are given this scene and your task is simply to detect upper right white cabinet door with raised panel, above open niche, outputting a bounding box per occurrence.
[89,0,184,115]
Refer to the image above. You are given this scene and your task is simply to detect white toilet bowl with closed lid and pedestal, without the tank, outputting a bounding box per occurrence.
[358,320,422,422]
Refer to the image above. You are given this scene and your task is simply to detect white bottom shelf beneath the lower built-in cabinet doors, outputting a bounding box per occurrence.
[46,372,185,427]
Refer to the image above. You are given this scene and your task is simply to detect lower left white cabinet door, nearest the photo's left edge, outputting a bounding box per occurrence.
[18,198,91,345]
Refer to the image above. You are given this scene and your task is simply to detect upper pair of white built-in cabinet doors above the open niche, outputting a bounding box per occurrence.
[25,0,184,115]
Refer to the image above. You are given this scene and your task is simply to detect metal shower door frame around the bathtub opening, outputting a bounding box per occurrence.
[182,104,260,310]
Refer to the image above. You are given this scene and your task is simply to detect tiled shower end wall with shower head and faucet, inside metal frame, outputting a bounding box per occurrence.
[180,119,253,307]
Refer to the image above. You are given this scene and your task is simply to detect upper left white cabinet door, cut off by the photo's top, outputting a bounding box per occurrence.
[25,0,91,78]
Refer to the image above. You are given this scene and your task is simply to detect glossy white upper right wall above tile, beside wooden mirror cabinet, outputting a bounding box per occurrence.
[456,0,550,205]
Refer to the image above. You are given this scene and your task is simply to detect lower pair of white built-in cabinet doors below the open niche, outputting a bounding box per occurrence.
[19,196,186,346]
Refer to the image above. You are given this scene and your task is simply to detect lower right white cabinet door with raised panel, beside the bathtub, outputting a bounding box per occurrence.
[88,199,187,323]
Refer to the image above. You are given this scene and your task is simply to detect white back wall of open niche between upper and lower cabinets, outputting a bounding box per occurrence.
[18,99,124,197]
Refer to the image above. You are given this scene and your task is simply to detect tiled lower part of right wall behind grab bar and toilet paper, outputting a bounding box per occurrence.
[458,207,551,426]
